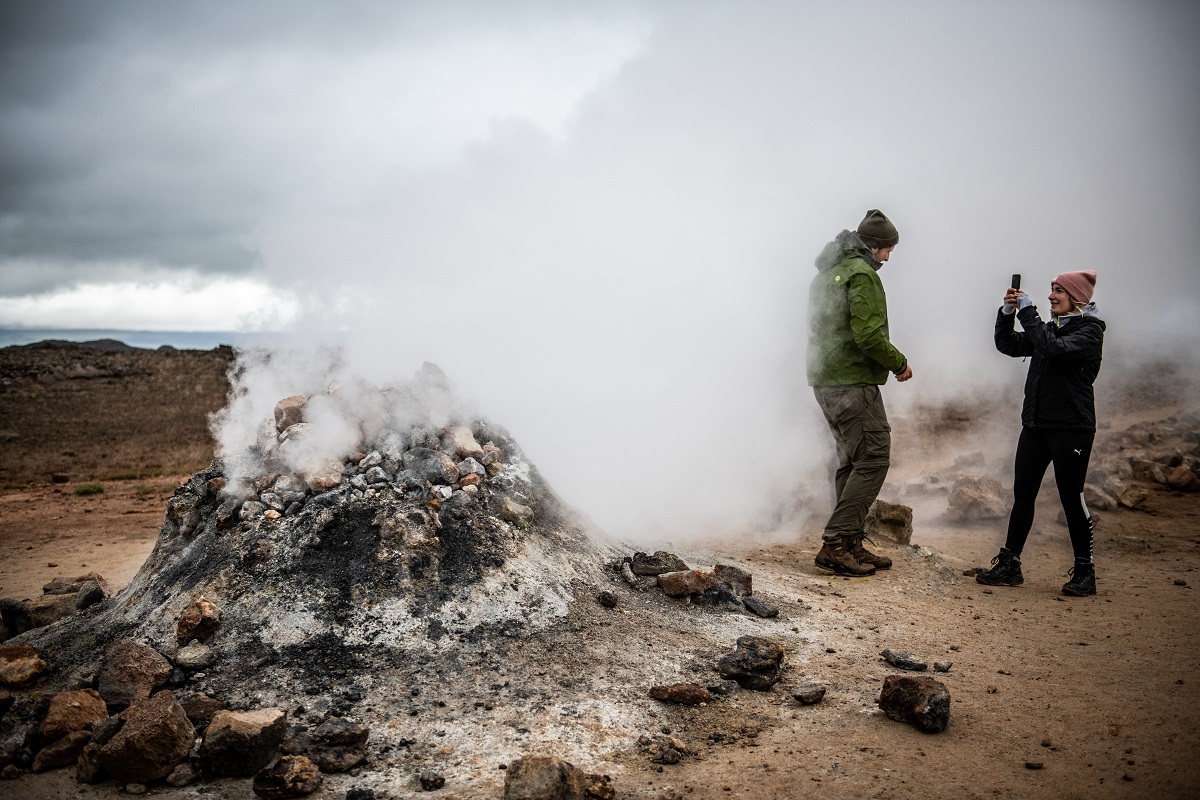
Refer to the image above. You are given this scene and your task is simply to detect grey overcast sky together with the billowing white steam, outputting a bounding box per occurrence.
[0,0,1200,537]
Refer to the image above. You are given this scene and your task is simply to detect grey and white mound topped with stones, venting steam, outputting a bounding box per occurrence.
[19,373,611,698]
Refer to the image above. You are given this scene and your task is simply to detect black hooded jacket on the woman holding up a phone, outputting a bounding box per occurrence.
[996,306,1105,431]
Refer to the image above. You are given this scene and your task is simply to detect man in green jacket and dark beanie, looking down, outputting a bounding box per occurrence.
[808,209,912,576]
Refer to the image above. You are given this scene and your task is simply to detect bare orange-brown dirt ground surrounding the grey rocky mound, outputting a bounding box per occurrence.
[0,425,1200,800]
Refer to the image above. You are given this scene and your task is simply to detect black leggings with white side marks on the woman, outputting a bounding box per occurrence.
[1004,428,1096,561]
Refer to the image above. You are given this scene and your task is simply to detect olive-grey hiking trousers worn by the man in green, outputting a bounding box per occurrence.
[812,386,892,542]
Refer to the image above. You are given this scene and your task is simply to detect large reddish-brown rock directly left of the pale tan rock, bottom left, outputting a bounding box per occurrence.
[97,691,196,784]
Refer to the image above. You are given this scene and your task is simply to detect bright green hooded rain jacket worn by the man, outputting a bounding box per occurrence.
[808,230,907,386]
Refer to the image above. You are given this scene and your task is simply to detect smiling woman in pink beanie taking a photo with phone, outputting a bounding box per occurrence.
[976,270,1104,596]
